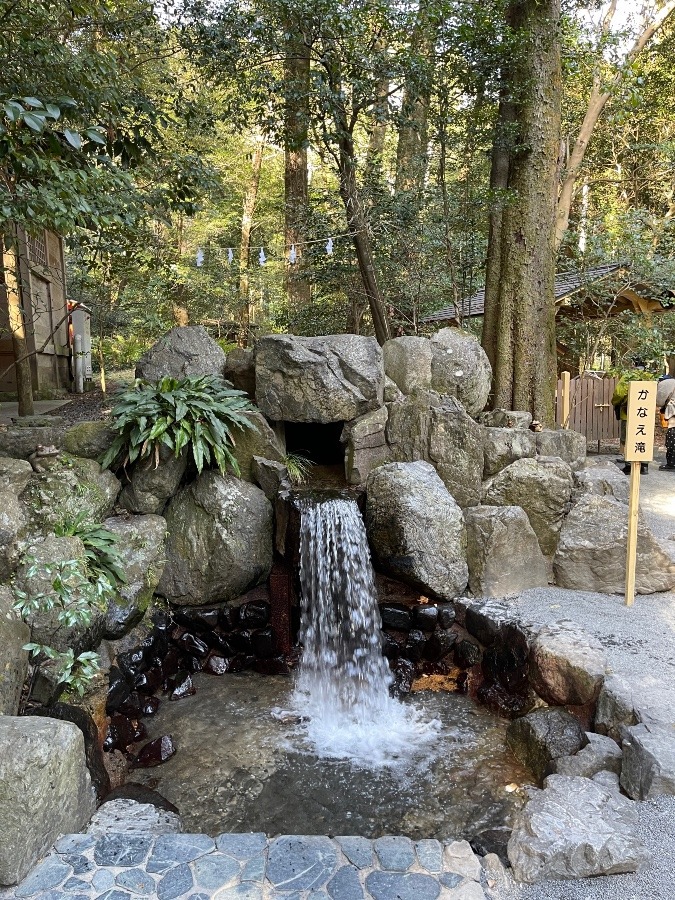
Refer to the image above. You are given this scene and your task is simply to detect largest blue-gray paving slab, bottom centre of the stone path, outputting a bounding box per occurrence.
[267,836,338,891]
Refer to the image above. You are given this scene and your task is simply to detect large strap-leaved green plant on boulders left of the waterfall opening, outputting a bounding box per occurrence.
[101,375,255,475]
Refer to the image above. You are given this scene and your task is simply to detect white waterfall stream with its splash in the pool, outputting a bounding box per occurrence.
[293,500,440,768]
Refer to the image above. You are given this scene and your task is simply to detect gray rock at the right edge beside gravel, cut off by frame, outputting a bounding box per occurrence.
[621,724,675,800]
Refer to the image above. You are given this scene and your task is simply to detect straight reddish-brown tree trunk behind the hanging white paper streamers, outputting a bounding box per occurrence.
[284,20,311,310]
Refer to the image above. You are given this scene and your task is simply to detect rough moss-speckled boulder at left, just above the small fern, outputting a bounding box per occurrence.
[21,453,121,533]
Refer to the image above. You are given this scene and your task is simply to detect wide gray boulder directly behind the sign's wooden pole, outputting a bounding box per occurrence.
[553,494,675,594]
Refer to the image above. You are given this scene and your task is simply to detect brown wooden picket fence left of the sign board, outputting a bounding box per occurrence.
[556,373,619,452]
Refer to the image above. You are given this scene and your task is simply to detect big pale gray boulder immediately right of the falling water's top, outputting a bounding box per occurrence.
[366,462,468,599]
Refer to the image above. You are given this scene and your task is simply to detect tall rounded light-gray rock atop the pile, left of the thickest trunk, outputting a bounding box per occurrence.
[431,328,492,416]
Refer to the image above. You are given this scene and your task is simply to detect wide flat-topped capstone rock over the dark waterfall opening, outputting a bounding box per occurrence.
[255,334,384,423]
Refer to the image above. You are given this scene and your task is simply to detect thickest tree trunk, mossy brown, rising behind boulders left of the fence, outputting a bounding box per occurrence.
[485,0,560,424]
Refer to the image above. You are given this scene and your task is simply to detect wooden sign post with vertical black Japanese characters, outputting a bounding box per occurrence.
[624,381,657,606]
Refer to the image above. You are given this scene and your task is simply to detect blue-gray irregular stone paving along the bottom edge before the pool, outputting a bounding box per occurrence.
[0,832,485,900]
